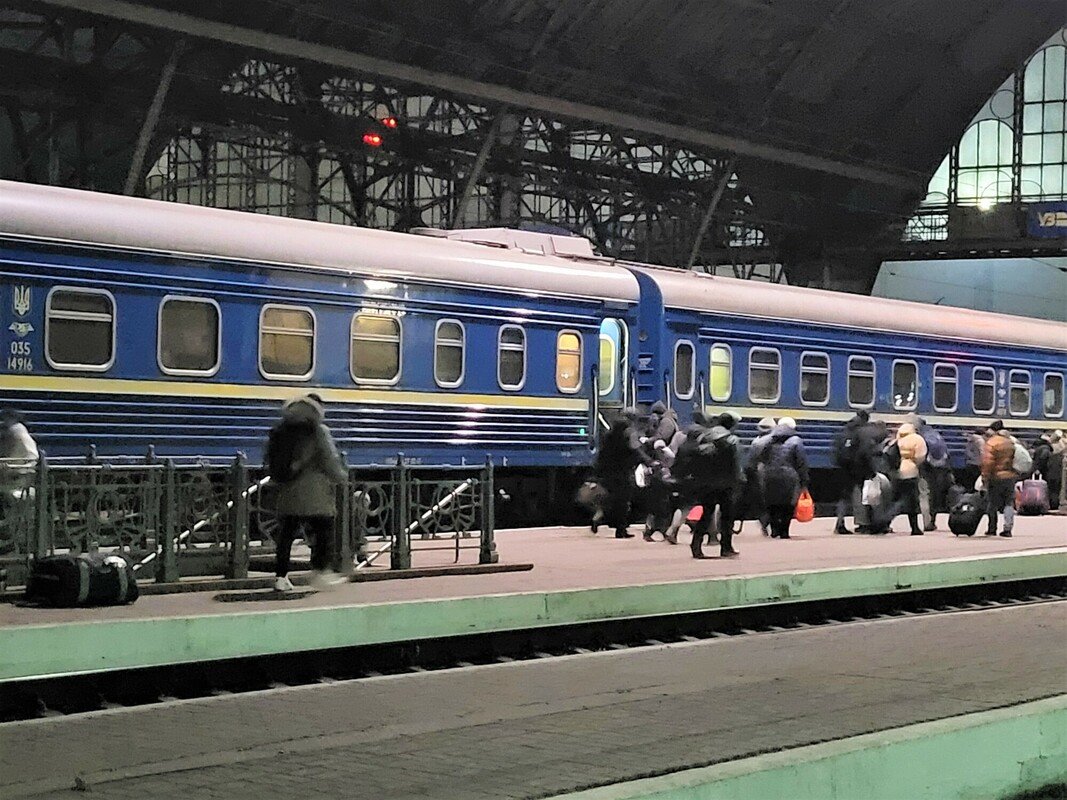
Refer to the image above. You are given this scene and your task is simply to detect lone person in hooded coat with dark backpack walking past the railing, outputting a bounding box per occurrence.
[267,395,348,592]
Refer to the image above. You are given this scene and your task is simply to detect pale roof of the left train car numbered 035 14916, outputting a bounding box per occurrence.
[0,181,638,302]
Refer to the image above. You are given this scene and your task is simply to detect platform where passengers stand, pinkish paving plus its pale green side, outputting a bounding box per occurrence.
[0,516,1067,682]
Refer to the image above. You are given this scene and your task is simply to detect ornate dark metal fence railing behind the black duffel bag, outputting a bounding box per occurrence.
[0,452,497,586]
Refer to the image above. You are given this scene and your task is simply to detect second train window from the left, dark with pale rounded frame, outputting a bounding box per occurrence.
[157,298,221,375]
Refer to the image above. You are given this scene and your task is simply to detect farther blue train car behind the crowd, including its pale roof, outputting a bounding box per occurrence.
[634,266,1067,467]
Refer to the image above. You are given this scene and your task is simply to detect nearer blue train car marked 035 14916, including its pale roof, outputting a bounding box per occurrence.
[0,182,637,467]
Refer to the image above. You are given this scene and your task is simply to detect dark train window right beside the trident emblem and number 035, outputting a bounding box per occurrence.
[45,288,115,371]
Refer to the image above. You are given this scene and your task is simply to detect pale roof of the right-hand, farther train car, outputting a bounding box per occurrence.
[635,266,1067,351]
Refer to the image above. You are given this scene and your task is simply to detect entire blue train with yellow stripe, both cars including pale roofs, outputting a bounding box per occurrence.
[0,182,1067,507]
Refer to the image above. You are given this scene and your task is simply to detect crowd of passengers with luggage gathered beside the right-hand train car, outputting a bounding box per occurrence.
[579,402,1067,558]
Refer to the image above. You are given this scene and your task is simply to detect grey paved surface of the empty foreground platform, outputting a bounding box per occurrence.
[0,602,1067,800]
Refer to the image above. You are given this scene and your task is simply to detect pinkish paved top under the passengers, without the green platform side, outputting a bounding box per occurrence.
[0,515,1067,627]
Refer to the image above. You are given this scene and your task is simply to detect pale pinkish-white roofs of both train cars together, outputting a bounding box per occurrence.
[0,186,1067,351]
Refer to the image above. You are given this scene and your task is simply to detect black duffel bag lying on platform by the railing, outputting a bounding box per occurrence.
[26,553,140,608]
